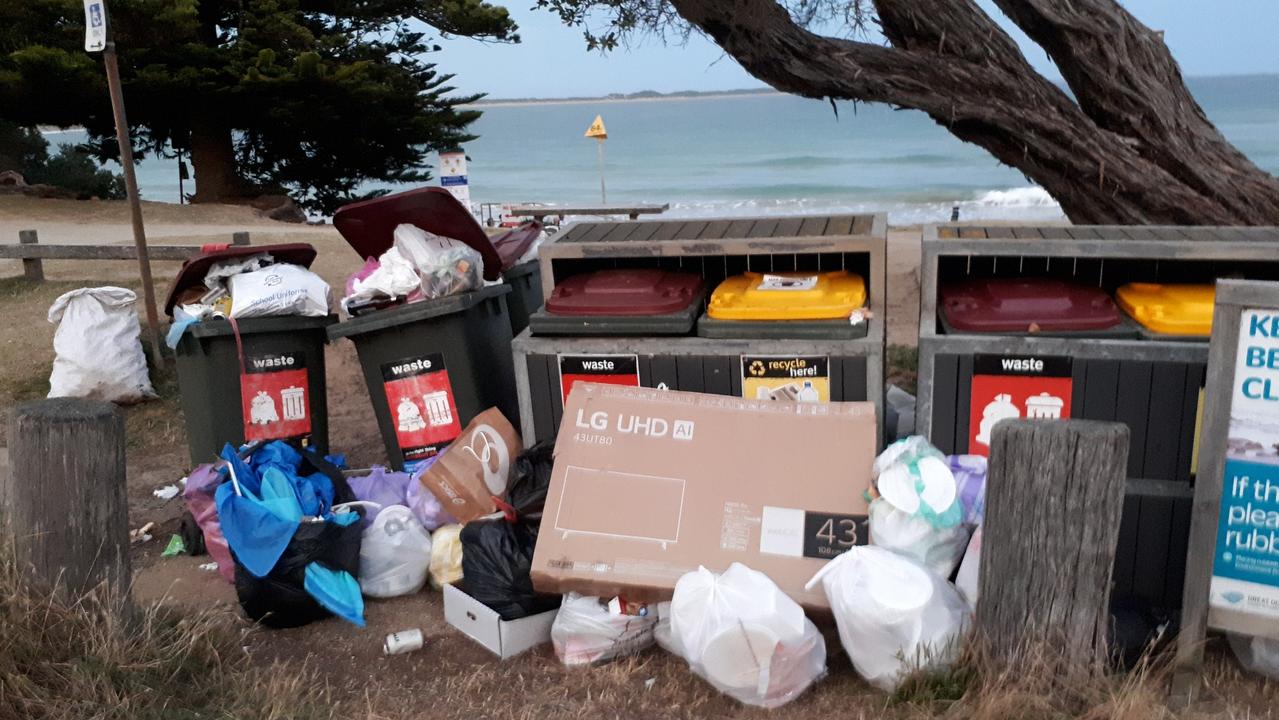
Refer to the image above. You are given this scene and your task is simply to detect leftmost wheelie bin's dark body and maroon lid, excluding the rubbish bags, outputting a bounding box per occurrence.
[164,243,336,464]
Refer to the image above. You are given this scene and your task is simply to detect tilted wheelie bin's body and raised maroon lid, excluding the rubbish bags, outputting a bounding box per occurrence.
[329,188,519,469]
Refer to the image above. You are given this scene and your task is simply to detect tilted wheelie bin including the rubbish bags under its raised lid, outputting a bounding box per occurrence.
[329,188,518,469]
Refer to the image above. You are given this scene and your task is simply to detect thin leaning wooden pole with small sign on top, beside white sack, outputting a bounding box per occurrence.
[84,0,164,367]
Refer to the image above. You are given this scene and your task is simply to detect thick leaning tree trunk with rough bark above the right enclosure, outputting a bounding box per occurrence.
[671,0,1279,225]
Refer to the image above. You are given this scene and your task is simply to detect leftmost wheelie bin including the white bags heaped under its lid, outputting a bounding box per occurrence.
[165,243,336,464]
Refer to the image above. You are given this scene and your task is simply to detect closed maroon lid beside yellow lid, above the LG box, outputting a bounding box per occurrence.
[546,270,702,316]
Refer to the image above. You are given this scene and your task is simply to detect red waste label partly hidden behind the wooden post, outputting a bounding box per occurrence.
[968,356,1073,457]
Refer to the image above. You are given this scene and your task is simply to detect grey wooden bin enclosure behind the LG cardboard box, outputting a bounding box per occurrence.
[512,215,888,444]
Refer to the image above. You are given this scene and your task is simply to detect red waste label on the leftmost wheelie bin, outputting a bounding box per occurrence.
[240,353,311,442]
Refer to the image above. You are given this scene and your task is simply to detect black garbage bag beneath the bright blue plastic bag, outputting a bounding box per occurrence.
[231,449,363,628]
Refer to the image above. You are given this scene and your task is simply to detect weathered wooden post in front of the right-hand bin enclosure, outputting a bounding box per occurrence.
[976,419,1128,679]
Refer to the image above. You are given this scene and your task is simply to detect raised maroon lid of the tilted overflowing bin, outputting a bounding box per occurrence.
[333,188,501,280]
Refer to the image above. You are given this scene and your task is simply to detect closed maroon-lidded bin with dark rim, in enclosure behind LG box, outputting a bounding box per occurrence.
[530,269,706,335]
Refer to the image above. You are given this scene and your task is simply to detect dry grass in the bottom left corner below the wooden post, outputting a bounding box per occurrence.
[0,559,335,720]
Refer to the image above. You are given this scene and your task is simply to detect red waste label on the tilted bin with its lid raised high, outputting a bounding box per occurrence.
[382,353,462,462]
